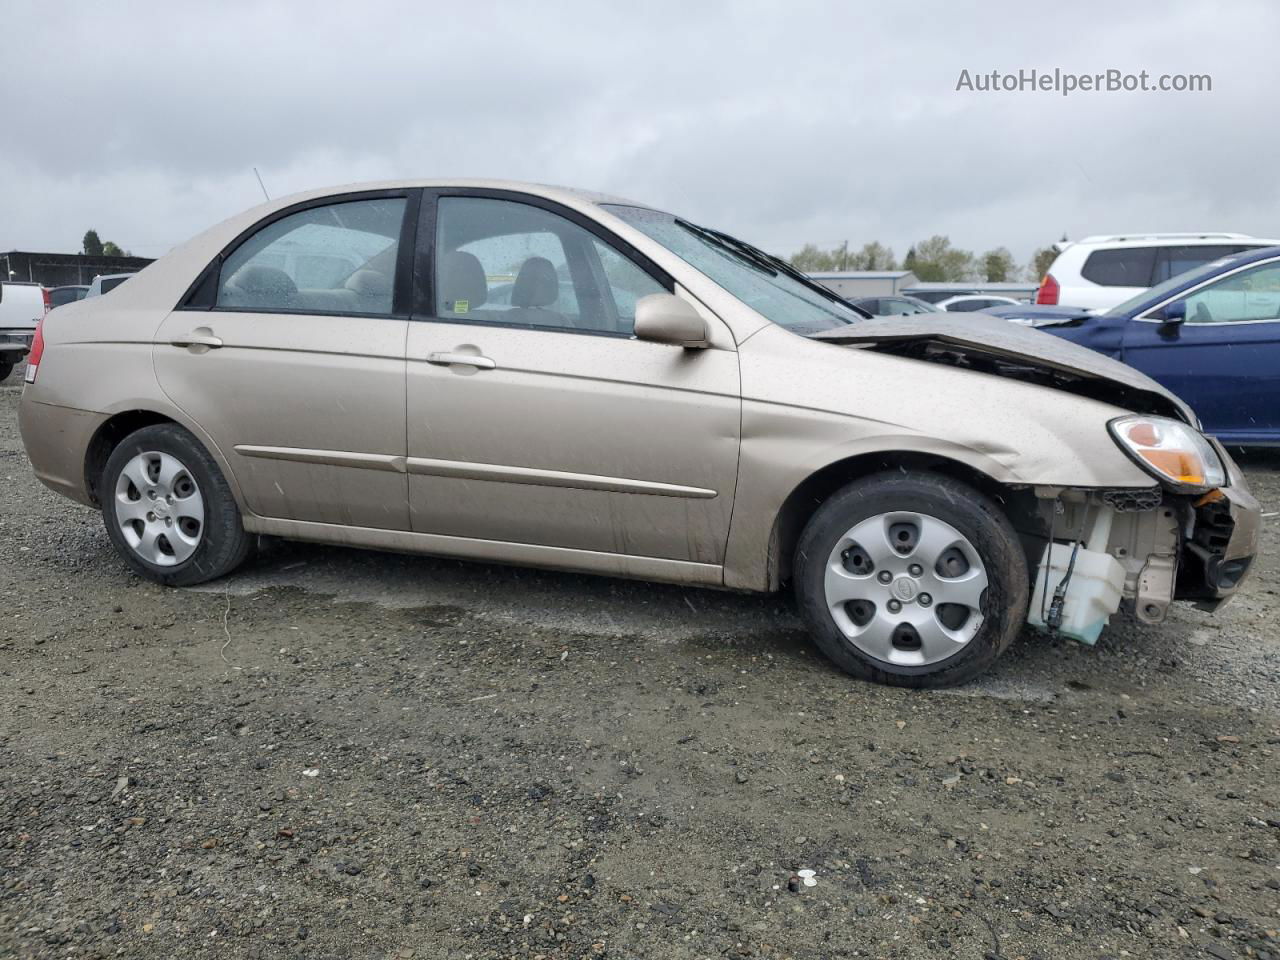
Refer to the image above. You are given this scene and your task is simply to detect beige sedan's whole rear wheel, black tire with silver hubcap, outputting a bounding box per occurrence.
[99,424,253,586]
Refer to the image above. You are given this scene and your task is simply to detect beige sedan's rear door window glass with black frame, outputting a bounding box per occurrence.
[216,197,407,315]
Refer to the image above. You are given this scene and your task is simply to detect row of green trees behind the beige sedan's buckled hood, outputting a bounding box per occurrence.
[791,236,1065,283]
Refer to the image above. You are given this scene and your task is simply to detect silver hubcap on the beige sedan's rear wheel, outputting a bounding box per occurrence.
[115,451,205,567]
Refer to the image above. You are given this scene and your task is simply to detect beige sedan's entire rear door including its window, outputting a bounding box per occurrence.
[154,191,420,530]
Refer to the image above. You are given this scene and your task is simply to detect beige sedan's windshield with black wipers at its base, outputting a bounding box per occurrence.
[604,204,863,335]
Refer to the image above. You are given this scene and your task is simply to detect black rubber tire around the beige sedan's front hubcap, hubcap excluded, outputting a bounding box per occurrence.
[794,472,1029,687]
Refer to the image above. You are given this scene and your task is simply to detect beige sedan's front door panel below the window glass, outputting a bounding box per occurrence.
[407,321,741,564]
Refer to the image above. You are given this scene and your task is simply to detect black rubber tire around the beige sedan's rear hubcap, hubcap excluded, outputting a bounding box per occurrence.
[99,424,255,586]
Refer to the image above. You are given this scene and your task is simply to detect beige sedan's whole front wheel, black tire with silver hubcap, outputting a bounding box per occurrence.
[795,472,1028,687]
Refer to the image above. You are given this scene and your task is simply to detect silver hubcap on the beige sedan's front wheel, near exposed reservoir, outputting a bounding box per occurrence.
[824,511,987,666]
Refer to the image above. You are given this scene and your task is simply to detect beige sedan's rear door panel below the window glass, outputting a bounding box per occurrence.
[154,310,408,530]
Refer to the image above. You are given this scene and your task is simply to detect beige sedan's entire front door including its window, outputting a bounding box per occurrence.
[407,193,741,568]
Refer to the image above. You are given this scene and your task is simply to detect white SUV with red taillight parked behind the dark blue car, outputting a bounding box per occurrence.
[1036,233,1280,311]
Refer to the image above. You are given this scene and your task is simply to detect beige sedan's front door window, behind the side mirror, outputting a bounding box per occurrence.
[434,197,667,335]
